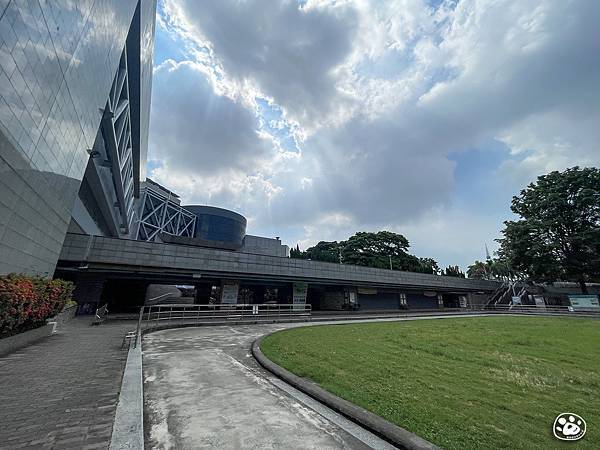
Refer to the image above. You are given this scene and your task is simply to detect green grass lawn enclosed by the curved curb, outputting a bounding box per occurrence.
[261,316,600,449]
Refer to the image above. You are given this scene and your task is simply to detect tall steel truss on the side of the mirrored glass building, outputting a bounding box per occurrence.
[102,46,134,234]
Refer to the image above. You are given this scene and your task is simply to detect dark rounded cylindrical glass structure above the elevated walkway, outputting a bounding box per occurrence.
[185,206,246,247]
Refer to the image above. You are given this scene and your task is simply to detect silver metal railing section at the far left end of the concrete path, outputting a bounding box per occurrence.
[136,303,312,345]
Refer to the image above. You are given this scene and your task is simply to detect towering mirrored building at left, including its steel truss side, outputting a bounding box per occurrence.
[0,0,156,275]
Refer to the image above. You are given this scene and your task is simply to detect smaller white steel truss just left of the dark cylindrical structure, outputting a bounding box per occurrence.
[137,188,196,241]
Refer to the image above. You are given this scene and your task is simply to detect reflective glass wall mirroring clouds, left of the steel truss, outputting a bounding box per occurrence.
[0,0,155,275]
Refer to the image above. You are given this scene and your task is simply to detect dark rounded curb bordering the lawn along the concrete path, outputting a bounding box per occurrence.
[252,333,440,450]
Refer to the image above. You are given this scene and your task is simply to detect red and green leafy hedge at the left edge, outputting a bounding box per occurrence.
[0,274,74,337]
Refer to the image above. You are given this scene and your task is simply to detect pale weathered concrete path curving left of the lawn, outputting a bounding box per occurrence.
[144,324,400,449]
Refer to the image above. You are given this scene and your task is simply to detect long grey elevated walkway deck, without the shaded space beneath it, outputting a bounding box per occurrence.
[58,233,500,294]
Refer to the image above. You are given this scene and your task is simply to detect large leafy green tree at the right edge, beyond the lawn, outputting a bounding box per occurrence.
[498,167,600,293]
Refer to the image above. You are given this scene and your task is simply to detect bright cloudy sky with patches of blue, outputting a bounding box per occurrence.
[148,0,600,269]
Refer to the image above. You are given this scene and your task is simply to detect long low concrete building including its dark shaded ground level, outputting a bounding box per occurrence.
[58,234,500,311]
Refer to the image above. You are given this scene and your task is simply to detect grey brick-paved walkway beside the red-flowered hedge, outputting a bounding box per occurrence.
[0,317,136,449]
